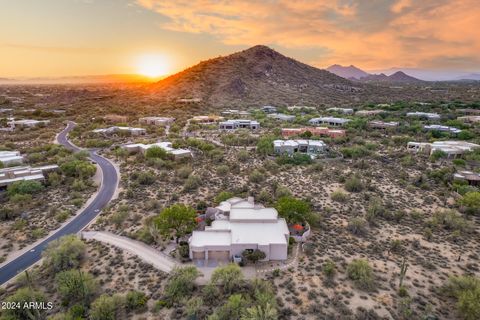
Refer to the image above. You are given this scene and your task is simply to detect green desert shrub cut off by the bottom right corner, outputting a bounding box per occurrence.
[443,276,480,320]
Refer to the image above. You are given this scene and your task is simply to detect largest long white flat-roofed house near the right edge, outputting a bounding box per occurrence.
[407,141,480,158]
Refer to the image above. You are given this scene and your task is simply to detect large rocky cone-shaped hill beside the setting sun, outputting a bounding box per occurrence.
[151,46,364,106]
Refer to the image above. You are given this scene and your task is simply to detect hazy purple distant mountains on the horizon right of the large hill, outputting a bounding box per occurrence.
[326,64,422,84]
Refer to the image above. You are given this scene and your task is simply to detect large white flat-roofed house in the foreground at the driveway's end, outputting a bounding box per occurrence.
[188,198,290,261]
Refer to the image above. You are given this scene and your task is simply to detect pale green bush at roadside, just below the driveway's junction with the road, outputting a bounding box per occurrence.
[42,235,86,272]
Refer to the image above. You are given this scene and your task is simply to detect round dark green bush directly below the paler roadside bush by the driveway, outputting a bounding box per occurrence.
[55,269,97,305]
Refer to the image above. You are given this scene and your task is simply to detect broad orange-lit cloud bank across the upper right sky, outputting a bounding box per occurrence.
[137,0,480,69]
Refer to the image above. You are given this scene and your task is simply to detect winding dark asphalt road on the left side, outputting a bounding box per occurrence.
[0,122,118,285]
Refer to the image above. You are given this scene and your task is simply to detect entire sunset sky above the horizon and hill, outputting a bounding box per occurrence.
[0,0,480,77]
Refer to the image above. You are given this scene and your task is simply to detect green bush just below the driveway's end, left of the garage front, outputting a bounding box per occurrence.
[165,266,200,302]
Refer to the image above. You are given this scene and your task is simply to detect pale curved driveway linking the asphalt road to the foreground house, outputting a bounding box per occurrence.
[82,231,177,272]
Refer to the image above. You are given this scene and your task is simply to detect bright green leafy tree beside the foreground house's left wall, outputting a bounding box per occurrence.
[154,204,197,243]
